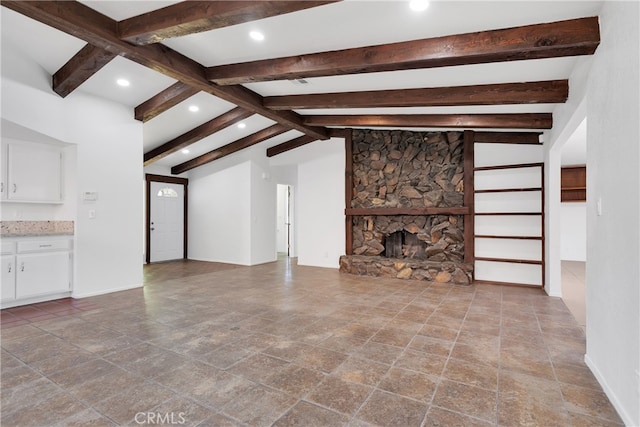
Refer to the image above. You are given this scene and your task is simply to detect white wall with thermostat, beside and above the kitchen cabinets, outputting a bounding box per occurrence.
[2,44,142,297]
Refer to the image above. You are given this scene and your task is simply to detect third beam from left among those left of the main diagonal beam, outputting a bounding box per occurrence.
[144,108,253,166]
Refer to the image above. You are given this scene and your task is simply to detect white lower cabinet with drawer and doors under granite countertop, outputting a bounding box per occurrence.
[0,237,73,308]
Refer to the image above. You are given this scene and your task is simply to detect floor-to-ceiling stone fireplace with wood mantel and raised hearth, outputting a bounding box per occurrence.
[340,130,472,284]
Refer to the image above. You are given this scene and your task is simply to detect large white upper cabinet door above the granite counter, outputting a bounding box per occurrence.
[5,144,62,202]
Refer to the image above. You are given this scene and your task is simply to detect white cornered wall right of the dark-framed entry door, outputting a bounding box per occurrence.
[187,146,276,265]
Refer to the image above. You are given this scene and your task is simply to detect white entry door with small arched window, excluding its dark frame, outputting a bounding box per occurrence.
[149,181,184,262]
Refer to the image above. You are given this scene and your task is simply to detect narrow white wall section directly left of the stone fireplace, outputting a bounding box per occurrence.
[296,138,345,268]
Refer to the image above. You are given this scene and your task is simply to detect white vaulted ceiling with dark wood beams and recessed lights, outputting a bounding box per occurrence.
[2,0,601,174]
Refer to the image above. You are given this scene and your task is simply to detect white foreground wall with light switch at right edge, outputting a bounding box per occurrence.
[585,2,640,425]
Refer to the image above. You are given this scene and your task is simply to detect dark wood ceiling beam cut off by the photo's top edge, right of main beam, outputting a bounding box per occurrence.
[118,1,342,45]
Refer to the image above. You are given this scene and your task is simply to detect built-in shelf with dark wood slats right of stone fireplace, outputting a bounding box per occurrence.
[465,138,545,287]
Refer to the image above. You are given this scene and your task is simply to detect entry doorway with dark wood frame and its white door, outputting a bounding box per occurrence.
[145,174,188,263]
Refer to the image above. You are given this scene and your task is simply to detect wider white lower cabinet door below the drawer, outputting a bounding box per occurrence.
[16,252,70,298]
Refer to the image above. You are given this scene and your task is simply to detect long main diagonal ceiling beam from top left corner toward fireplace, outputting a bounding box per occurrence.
[2,0,329,139]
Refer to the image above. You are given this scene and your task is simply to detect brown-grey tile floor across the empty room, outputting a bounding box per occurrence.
[0,260,621,427]
